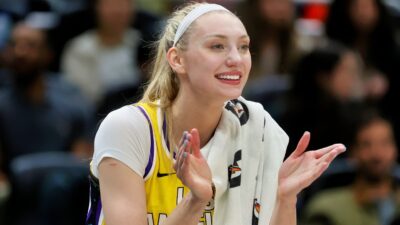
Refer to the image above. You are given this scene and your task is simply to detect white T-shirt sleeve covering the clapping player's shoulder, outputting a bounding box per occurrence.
[91,105,151,176]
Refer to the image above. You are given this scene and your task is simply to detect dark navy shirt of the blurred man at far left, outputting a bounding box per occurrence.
[0,77,92,171]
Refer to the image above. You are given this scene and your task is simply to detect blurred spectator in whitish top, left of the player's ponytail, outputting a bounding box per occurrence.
[62,0,144,112]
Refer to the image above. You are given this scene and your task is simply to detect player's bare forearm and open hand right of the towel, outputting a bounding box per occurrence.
[270,132,346,225]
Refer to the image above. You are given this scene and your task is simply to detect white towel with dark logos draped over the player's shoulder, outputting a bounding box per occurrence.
[207,98,289,225]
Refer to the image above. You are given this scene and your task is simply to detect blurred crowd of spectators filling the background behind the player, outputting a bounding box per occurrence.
[0,0,400,225]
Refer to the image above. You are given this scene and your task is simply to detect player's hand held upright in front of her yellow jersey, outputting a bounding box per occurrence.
[174,129,213,203]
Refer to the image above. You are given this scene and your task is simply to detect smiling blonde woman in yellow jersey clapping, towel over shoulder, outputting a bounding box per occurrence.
[87,3,345,225]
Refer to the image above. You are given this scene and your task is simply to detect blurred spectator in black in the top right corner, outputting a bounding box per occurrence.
[326,0,400,104]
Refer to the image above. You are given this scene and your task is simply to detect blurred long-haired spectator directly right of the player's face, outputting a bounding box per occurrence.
[238,0,301,119]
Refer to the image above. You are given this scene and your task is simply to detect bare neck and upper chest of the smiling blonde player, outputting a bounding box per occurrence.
[171,91,223,147]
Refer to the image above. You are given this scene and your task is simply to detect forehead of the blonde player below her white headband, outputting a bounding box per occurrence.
[191,11,247,38]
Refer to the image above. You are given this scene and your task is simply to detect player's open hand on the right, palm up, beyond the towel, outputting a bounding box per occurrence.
[278,132,346,200]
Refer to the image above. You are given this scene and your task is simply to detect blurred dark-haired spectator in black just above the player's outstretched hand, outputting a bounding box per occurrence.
[282,43,364,155]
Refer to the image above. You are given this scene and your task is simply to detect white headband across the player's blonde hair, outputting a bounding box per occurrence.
[173,4,230,46]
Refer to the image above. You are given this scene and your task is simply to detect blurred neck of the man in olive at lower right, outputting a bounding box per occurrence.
[353,178,392,204]
